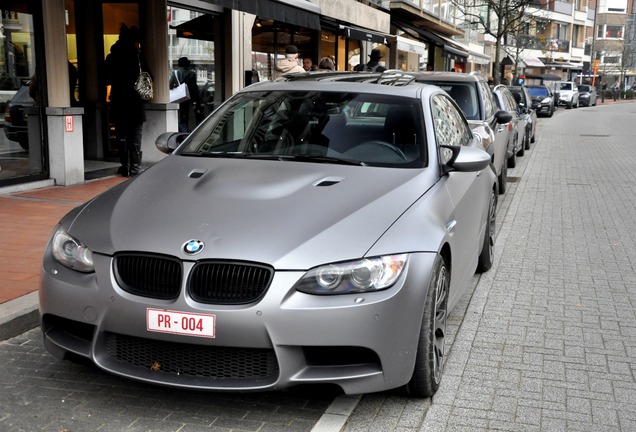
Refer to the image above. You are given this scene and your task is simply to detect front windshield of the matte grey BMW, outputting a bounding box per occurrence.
[177,91,425,167]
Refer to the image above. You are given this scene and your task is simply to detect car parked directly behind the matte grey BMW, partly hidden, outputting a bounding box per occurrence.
[409,72,512,193]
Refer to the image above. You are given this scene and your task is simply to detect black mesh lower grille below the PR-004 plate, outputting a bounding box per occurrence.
[106,333,279,385]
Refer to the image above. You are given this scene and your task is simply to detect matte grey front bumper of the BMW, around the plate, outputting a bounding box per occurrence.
[40,250,435,394]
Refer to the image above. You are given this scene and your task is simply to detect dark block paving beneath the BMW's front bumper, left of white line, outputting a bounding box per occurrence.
[0,328,335,432]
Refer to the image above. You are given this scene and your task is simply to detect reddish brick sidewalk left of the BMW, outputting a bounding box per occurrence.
[0,177,126,303]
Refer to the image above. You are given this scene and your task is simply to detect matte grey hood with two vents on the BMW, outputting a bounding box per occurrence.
[69,155,437,269]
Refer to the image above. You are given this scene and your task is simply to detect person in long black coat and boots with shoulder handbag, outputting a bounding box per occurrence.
[105,24,152,177]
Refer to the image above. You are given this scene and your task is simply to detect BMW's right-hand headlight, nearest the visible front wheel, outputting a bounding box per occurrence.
[294,254,408,294]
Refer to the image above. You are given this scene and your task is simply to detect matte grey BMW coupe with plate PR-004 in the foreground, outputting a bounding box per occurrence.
[40,74,497,397]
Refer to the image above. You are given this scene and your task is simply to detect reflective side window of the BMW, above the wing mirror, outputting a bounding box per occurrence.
[431,94,472,164]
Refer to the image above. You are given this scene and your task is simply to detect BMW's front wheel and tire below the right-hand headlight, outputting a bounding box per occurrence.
[405,255,450,398]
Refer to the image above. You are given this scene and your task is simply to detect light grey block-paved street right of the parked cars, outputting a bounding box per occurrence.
[344,103,636,432]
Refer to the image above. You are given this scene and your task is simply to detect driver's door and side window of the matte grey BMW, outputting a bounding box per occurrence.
[431,93,490,294]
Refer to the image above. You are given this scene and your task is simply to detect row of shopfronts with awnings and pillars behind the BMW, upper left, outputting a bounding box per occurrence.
[0,0,476,188]
